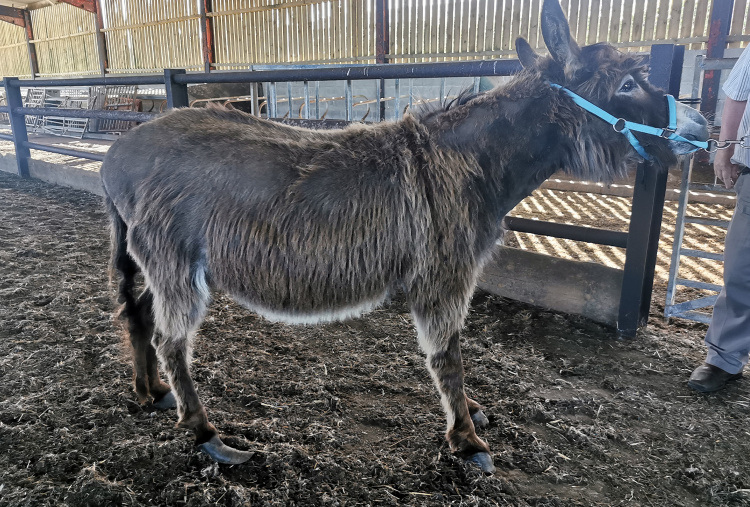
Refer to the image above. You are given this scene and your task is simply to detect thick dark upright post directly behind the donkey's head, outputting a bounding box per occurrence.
[617,44,685,337]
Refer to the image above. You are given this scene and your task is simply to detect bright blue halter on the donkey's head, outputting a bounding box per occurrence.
[550,83,708,160]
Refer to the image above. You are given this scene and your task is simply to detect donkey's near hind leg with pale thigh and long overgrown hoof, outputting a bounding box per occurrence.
[154,290,252,464]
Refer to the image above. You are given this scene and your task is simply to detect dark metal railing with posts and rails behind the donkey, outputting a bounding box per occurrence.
[0,44,684,336]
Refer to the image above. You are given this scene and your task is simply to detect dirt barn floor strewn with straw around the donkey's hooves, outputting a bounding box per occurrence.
[0,173,750,506]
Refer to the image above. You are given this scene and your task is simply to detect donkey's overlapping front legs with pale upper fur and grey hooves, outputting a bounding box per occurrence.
[414,313,495,473]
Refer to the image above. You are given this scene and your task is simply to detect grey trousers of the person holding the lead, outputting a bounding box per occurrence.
[705,169,750,373]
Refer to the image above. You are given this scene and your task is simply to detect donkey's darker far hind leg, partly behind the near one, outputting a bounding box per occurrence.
[123,289,177,410]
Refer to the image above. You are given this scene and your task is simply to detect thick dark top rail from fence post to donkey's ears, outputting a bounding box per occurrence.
[174,60,521,84]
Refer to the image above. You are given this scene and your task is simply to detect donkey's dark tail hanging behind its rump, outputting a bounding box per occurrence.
[104,196,140,315]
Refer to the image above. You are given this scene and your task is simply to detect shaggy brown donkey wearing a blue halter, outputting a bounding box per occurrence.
[101,0,708,473]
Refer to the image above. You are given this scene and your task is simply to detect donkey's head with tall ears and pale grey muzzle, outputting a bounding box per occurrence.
[516,0,708,167]
